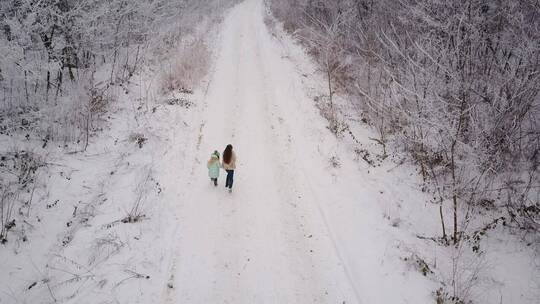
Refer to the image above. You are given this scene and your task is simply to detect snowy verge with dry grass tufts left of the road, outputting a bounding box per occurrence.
[0,61,205,303]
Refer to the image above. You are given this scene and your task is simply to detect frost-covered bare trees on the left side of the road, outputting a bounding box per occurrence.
[0,0,232,142]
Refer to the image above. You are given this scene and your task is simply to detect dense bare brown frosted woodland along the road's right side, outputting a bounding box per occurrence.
[272,0,540,244]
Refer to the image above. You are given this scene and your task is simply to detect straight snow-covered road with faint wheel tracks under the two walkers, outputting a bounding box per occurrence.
[162,1,354,303]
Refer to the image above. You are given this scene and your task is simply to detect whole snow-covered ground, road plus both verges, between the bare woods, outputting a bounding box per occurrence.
[0,0,540,304]
